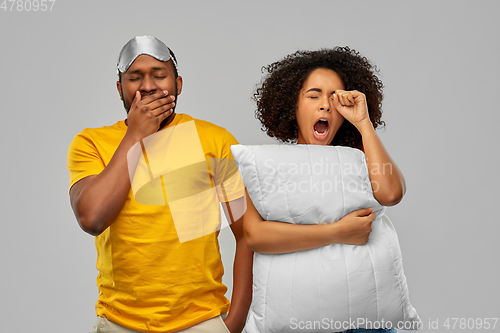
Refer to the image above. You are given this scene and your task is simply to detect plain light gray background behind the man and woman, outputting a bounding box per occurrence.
[0,0,500,333]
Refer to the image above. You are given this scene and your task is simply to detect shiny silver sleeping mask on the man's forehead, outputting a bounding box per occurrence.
[116,36,179,74]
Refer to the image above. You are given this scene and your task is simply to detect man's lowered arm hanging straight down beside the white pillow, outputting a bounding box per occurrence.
[222,197,253,333]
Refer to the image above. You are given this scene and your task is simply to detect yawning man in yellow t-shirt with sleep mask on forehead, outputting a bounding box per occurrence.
[68,36,253,333]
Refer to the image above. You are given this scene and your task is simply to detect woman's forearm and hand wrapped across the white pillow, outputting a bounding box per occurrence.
[243,193,375,254]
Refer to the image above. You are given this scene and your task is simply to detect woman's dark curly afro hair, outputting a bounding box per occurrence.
[253,46,385,148]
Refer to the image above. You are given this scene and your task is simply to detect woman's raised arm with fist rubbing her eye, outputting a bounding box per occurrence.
[333,90,406,206]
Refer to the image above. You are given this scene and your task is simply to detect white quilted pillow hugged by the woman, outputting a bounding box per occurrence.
[231,145,422,333]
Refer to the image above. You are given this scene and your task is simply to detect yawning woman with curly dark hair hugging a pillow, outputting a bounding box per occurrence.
[244,47,405,332]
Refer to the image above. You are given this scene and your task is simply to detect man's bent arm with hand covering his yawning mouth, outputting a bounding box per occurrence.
[70,91,173,236]
